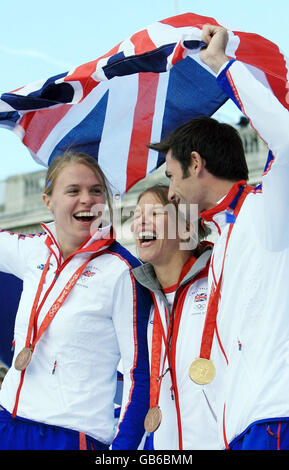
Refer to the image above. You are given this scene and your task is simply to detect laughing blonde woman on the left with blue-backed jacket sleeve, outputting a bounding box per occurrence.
[0,153,150,450]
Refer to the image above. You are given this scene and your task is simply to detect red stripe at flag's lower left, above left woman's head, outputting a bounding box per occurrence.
[19,104,73,153]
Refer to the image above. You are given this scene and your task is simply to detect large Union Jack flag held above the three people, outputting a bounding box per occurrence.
[0,13,289,194]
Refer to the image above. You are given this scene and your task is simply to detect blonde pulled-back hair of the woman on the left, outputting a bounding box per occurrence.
[44,151,112,218]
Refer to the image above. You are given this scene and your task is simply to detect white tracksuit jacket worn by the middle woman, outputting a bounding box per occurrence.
[133,247,218,450]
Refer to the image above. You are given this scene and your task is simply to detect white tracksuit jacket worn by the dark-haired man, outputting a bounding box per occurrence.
[203,61,289,448]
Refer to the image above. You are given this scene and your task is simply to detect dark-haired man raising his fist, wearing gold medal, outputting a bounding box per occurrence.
[147,25,289,450]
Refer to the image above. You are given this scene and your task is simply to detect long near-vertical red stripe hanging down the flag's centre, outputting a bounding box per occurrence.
[126,72,159,191]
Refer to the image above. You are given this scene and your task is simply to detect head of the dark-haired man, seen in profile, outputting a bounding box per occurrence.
[150,117,248,211]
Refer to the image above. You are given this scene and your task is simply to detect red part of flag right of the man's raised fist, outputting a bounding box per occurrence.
[236,31,289,109]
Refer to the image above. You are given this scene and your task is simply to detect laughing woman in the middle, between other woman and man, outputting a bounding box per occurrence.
[132,185,217,450]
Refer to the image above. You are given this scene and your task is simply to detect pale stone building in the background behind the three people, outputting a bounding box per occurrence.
[0,118,268,254]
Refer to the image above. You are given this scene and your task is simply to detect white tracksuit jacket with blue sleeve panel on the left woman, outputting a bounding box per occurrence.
[0,223,151,449]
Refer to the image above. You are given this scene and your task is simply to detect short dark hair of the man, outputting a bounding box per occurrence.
[148,116,248,181]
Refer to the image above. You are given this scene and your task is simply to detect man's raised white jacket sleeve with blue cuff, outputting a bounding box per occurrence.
[218,61,289,251]
